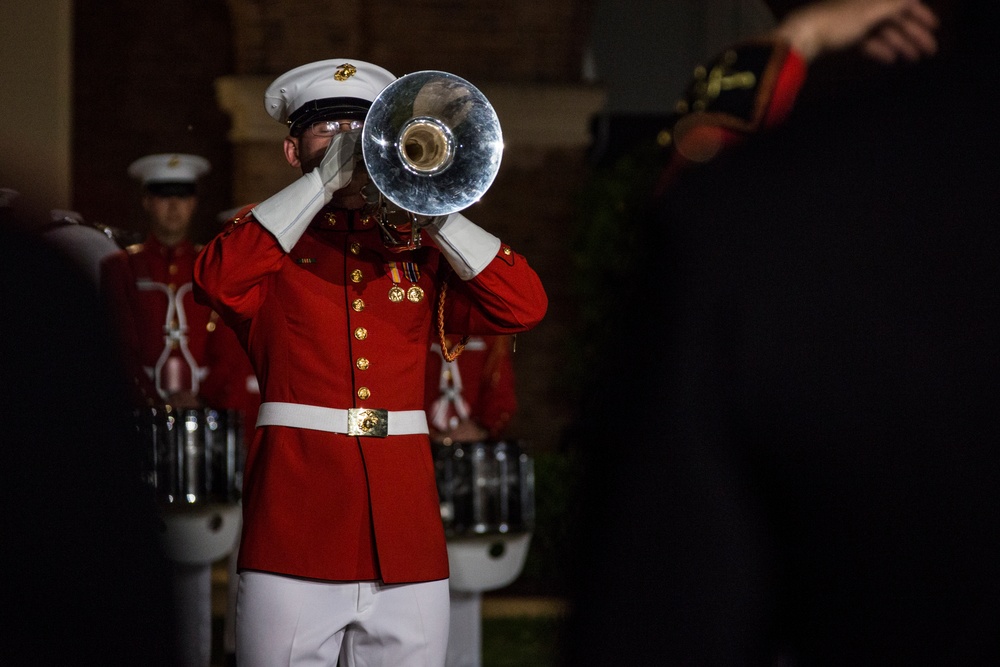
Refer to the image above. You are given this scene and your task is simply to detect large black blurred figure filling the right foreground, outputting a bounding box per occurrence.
[568,3,1000,667]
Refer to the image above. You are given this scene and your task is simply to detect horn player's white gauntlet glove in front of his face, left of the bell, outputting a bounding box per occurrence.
[253,130,361,252]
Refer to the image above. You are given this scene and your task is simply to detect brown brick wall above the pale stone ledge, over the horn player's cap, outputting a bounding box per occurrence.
[223,0,594,82]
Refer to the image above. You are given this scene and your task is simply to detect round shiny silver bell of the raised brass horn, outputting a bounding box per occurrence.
[361,70,503,216]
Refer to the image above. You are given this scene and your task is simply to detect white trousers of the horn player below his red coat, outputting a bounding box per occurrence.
[236,572,448,667]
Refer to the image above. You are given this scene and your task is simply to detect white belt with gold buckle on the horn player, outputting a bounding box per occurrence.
[257,401,428,438]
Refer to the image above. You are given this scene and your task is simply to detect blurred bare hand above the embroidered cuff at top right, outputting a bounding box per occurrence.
[774,0,938,64]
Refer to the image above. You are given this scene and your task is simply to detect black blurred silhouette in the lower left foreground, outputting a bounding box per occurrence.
[0,208,176,666]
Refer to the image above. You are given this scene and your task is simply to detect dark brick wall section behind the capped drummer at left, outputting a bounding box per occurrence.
[72,0,233,238]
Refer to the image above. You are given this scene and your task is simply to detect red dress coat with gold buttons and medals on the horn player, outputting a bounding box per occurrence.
[195,209,547,583]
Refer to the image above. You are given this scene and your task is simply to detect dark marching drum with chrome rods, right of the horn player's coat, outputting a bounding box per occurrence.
[433,440,535,538]
